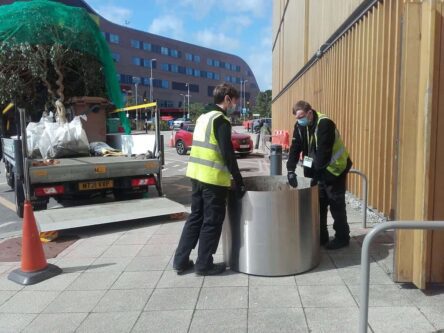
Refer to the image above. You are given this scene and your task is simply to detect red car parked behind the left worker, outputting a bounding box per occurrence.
[172,124,253,156]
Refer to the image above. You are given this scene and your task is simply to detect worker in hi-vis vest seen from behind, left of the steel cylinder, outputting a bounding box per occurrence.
[173,83,245,275]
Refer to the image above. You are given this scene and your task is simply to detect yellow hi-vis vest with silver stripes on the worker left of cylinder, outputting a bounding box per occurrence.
[186,111,231,187]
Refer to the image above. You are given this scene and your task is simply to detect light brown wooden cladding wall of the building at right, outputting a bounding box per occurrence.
[272,0,444,288]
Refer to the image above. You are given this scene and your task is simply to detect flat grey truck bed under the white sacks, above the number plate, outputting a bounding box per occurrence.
[29,156,161,184]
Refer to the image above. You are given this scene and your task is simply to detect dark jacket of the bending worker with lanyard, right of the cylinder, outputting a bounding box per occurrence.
[287,110,352,183]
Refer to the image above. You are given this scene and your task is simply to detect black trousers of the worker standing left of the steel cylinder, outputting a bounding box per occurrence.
[173,179,228,270]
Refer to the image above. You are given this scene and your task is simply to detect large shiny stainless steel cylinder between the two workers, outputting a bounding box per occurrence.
[222,176,320,276]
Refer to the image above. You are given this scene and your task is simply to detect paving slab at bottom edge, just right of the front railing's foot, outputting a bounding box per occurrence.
[368,306,435,333]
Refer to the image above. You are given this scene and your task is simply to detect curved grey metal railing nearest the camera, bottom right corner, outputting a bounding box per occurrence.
[359,221,444,333]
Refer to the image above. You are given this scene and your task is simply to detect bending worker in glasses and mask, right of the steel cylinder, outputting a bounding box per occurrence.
[287,101,352,250]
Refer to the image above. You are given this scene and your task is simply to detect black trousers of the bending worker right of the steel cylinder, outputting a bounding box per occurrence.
[319,172,350,240]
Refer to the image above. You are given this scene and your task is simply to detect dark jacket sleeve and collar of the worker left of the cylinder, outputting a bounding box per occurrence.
[213,105,244,186]
